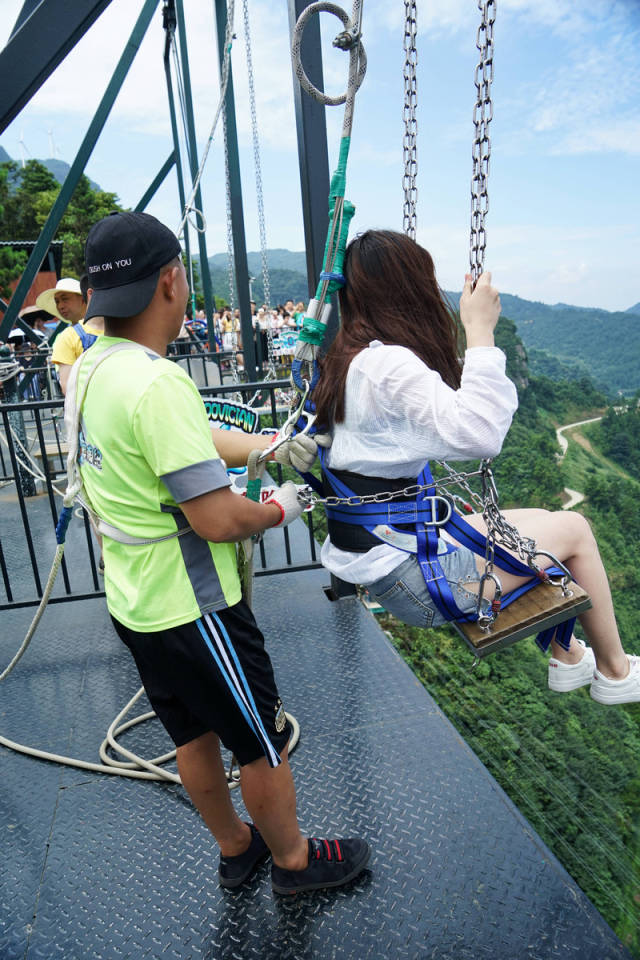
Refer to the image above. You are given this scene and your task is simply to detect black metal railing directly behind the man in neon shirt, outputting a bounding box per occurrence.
[0,380,321,610]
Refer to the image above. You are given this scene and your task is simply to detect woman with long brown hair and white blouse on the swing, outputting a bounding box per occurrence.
[313,230,640,703]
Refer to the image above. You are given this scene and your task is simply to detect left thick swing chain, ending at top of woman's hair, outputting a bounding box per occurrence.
[402,0,418,240]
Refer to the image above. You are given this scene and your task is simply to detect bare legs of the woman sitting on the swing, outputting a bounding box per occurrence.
[452,510,629,680]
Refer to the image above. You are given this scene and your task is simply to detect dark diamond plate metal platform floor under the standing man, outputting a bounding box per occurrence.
[0,571,629,960]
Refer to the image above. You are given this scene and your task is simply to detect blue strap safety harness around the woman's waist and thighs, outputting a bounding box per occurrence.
[320,448,575,652]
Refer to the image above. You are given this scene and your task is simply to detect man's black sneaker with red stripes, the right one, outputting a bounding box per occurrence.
[271,837,371,893]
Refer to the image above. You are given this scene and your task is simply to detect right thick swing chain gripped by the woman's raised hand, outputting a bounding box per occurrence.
[469,0,496,281]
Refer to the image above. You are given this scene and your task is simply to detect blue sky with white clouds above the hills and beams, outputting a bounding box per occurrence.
[0,0,640,310]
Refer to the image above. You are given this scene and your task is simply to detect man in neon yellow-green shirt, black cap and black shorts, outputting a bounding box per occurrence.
[72,213,369,893]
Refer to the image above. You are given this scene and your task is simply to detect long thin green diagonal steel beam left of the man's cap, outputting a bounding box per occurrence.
[0,0,158,340]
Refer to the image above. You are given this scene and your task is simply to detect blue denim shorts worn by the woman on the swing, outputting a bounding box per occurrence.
[367,547,489,627]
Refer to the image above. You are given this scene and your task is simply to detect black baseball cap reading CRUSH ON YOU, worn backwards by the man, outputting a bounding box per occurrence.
[85,212,181,320]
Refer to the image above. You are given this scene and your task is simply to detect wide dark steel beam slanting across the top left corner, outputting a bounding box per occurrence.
[0,0,111,133]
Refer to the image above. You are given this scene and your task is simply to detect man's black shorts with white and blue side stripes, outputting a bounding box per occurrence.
[111,601,291,767]
